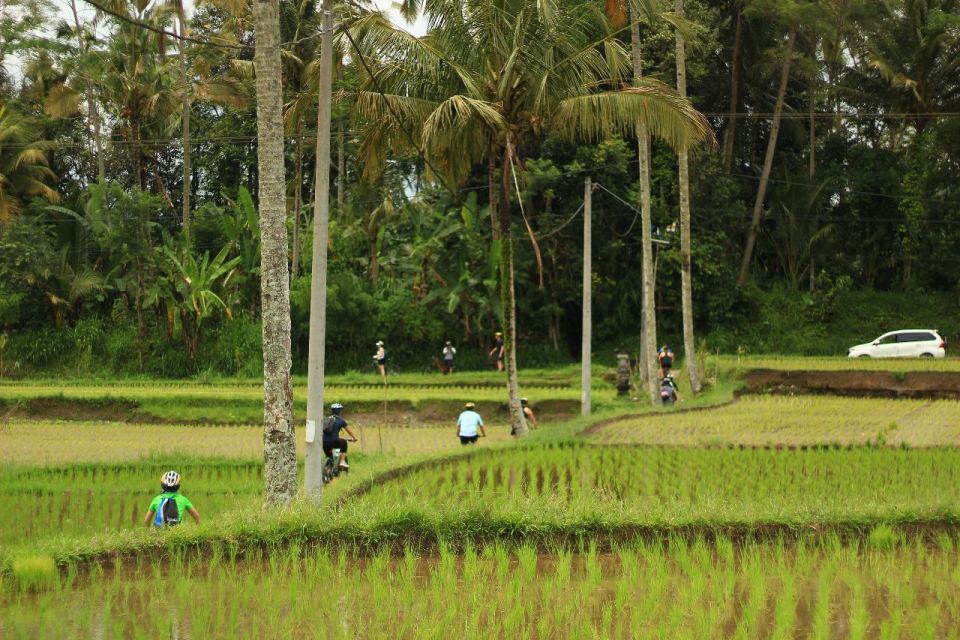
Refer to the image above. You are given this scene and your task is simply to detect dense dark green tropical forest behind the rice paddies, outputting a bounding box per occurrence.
[0,0,960,376]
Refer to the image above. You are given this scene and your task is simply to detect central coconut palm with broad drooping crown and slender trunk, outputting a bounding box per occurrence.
[353,0,711,435]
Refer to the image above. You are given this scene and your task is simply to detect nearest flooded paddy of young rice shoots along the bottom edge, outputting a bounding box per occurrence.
[0,536,960,639]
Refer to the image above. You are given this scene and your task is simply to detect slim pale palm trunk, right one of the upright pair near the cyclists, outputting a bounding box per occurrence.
[674,0,701,393]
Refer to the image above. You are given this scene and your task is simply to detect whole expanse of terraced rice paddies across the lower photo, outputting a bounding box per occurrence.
[0,368,960,639]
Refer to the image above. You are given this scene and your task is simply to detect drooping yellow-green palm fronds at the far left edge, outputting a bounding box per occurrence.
[0,104,60,222]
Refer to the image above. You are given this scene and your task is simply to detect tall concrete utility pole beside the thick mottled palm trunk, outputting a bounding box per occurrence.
[304,0,333,502]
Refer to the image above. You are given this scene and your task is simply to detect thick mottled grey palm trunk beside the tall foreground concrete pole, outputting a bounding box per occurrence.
[254,0,297,505]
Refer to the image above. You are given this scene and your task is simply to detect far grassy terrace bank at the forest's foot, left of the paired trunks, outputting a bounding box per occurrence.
[0,368,618,424]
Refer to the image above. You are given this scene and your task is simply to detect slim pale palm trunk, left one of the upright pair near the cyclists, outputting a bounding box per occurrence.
[630,3,660,404]
